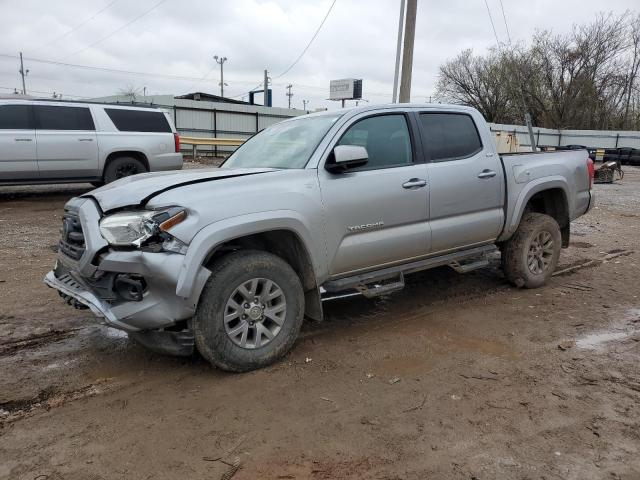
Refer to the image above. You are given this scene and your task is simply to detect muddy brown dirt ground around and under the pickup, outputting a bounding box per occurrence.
[0,163,640,480]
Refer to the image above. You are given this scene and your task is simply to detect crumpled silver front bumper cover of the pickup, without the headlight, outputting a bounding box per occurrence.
[44,199,210,332]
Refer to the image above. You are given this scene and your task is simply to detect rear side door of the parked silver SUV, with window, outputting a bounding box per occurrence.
[33,105,99,179]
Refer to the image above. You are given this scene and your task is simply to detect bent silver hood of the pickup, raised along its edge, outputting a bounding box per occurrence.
[83,168,276,212]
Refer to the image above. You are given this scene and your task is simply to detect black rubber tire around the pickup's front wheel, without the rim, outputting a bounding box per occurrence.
[193,250,304,372]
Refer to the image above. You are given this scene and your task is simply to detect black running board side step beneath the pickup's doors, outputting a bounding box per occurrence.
[322,245,496,297]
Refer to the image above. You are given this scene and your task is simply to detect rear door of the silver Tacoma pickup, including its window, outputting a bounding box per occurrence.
[418,111,504,253]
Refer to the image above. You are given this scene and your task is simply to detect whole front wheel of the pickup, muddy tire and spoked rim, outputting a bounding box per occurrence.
[193,250,304,372]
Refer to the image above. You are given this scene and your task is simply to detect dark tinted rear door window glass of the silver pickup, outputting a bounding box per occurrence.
[420,113,482,162]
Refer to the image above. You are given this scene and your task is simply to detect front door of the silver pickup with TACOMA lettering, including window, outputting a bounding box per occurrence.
[318,113,430,276]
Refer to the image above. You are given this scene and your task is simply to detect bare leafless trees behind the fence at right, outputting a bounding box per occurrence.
[437,12,640,129]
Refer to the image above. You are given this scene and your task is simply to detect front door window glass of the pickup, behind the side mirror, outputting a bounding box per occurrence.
[338,114,413,170]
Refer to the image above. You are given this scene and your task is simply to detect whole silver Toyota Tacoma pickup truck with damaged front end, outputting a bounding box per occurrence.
[45,104,593,371]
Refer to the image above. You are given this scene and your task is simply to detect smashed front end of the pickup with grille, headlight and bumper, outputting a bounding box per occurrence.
[44,198,210,355]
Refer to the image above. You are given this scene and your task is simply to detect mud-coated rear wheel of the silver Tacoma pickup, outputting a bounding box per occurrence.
[502,213,562,288]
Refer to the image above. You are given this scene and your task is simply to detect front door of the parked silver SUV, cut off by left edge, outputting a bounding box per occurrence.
[0,103,38,181]
